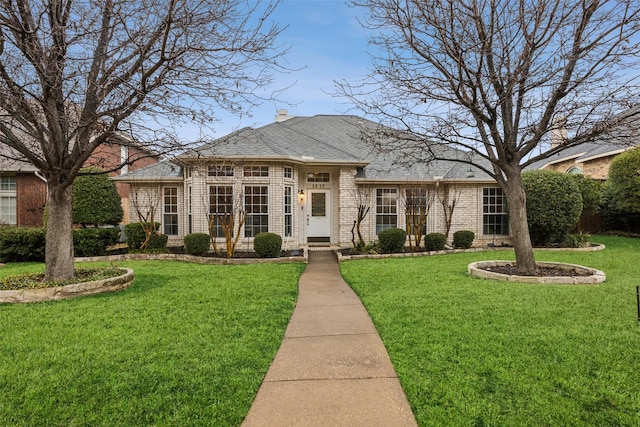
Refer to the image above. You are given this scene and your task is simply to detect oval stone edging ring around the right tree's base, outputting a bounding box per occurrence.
[467,260,607,285]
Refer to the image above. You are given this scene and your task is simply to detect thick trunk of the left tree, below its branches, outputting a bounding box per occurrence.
[45,179,75,280]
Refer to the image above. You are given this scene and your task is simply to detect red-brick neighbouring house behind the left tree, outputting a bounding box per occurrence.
[0,137,158,227]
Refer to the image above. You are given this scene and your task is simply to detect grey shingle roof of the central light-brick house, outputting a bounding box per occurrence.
[172,115,489,181]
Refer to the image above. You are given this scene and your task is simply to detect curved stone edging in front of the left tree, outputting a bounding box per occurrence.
[0,268,135,303]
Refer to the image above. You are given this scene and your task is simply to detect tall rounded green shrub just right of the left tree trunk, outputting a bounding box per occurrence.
[72,168,123,226]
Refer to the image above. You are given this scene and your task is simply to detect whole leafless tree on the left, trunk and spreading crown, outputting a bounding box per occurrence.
[0,0,284,279]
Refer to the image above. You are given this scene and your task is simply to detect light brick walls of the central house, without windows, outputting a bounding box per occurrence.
[130,162,509,251]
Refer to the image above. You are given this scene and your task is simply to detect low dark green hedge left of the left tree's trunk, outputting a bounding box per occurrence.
[0,227,46,262]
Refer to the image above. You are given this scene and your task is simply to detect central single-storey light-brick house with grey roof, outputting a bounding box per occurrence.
[115,110,509,250]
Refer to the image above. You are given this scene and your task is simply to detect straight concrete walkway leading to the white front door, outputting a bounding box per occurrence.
[242,252,417,427]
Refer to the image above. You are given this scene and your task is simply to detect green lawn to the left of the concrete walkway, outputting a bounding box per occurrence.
[0,261,304,426]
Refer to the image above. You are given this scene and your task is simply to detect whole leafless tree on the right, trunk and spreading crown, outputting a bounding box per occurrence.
[338,0,640,275]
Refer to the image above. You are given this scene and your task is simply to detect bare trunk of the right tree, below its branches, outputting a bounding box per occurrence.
[503,173,536,276]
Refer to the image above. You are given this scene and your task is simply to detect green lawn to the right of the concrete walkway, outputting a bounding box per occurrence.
[341,236,640,426]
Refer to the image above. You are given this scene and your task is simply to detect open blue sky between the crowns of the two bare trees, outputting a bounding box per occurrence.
[183,0,371,139]
